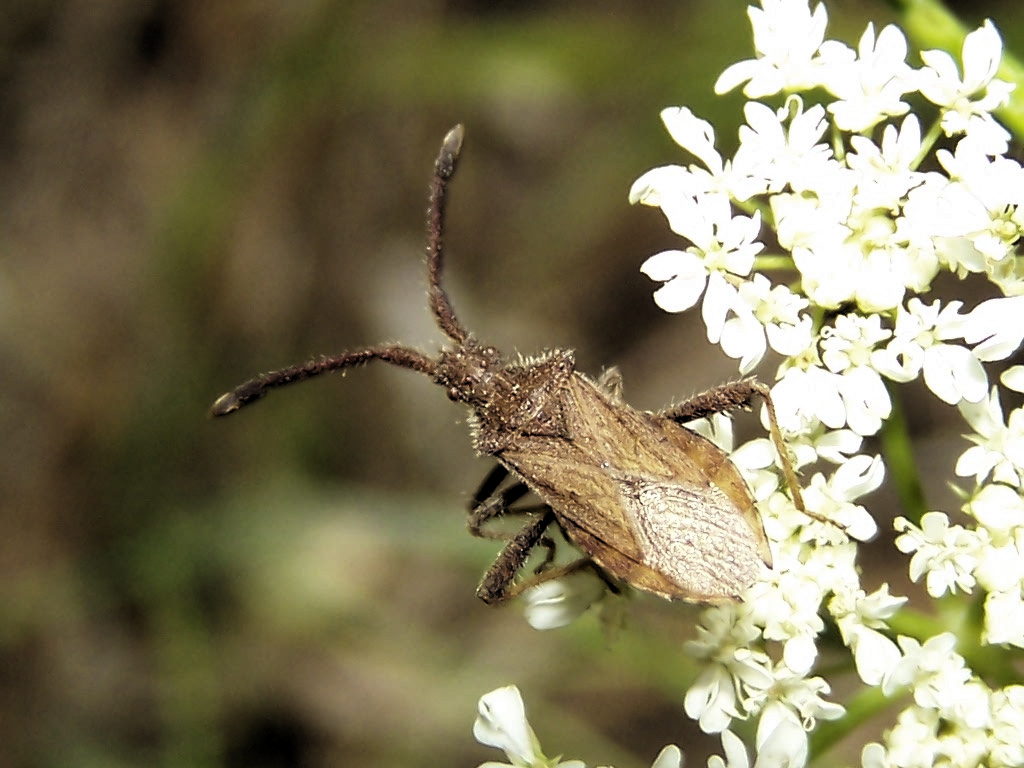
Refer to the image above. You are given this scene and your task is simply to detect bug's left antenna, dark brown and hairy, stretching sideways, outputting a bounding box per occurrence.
[210,345,437,416]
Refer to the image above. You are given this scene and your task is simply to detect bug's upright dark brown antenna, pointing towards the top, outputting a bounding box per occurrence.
[427,124,469,344]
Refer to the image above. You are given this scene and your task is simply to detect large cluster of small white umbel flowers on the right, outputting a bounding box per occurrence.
[475,0,1024,768]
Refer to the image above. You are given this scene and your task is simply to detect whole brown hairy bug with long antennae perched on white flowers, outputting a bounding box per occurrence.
[211,125,804,603]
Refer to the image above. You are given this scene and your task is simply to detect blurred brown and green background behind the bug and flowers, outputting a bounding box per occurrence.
[0,0,1019,768]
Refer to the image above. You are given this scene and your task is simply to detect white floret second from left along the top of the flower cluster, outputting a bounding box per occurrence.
[827,24,914,132]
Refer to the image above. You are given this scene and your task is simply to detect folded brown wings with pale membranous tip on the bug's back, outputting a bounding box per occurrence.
[499,375,771,602]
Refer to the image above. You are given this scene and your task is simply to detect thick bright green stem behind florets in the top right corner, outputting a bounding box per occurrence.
[890,0,1024,137]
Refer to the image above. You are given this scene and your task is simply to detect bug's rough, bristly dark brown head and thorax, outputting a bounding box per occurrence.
[435,341,575,454]
